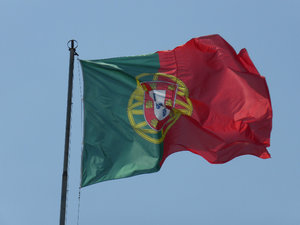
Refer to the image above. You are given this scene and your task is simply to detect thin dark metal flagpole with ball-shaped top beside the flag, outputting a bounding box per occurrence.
[59,40,78,225]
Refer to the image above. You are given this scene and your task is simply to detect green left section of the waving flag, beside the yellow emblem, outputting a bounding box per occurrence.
[80,53,163,187]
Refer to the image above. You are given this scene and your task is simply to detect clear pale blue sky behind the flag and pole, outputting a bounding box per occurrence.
[0,0,300,225]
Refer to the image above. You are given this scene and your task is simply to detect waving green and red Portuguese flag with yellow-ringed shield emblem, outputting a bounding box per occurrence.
[80,35,272,187]
